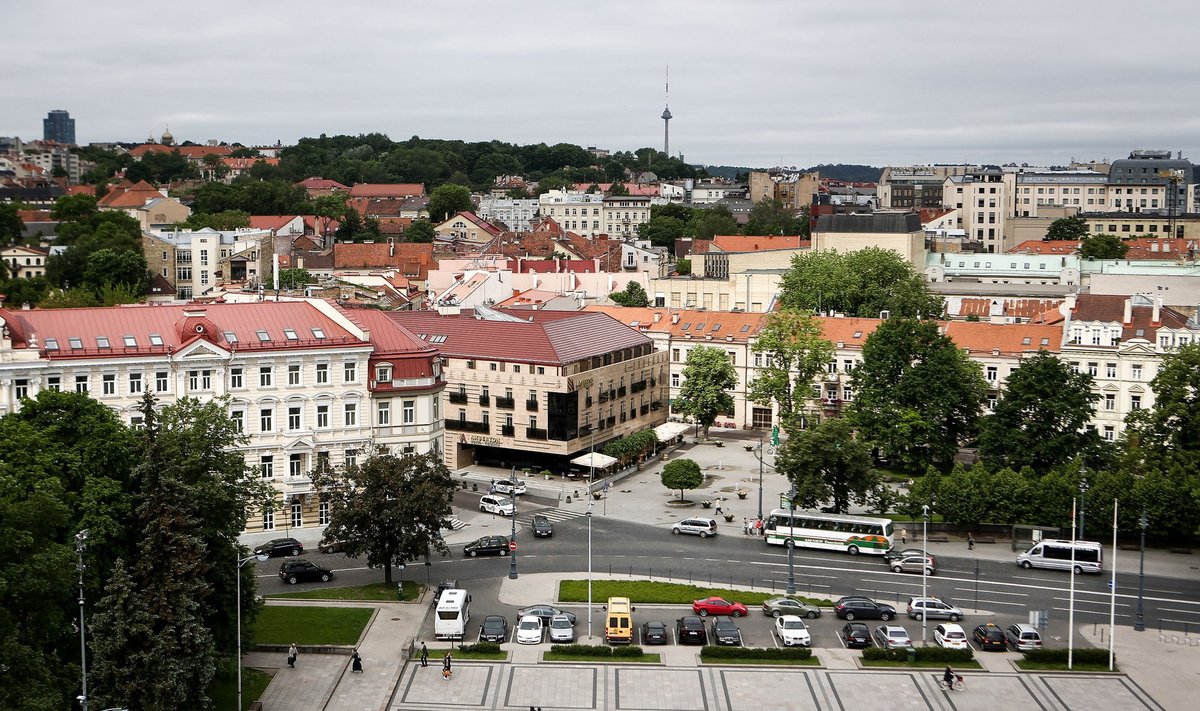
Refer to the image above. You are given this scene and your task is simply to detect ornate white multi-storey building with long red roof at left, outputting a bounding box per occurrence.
[0,299,444,531]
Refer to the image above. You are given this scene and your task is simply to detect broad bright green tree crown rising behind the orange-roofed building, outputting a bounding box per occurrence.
[780,247,942,318]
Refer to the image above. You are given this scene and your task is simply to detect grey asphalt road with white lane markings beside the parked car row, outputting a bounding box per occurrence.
[257,515,1200,647]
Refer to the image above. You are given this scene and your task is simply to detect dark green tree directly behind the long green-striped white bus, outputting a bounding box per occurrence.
[775,418,878,513]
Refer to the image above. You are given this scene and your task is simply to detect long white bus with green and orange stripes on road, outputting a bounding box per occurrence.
[763,508,892,555]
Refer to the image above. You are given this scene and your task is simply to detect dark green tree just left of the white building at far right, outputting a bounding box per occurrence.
[979,351,1100,474]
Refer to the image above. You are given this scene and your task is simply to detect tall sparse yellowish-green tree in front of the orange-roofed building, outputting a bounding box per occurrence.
[748,310,834,426]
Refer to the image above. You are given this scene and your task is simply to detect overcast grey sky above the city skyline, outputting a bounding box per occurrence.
[0,0,1200,167]
